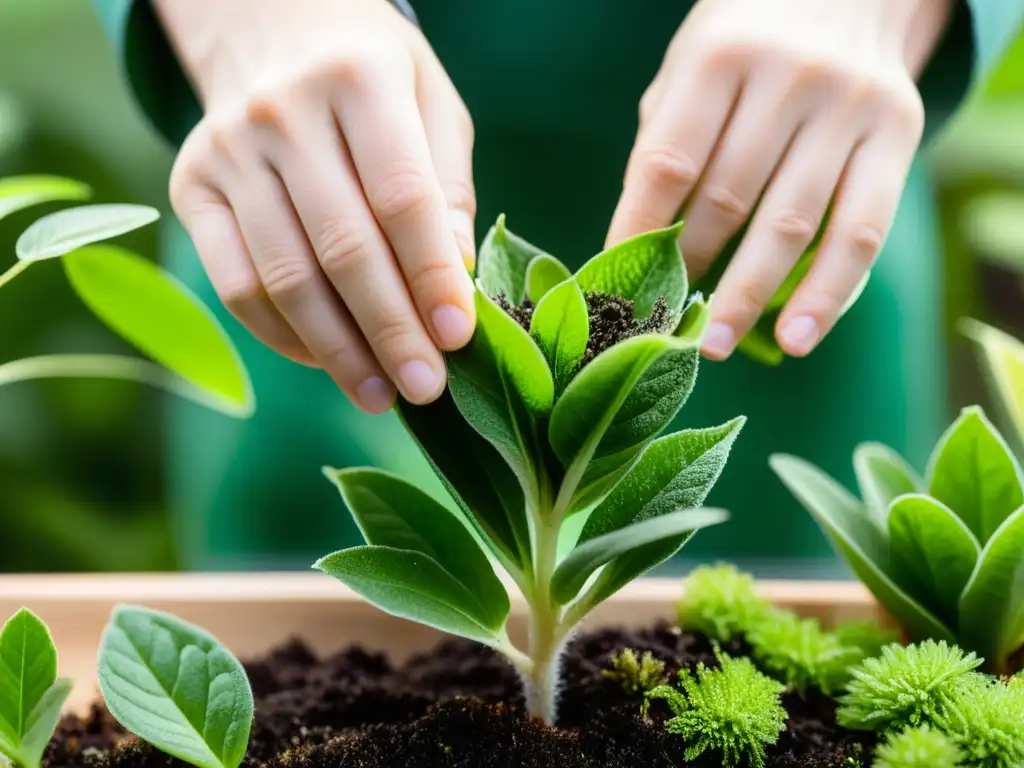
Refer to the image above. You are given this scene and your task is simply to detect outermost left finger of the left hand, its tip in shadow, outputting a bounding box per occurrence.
[175,187,315,366]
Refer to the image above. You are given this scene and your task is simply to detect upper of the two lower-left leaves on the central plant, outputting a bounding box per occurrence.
[324,468,509,626]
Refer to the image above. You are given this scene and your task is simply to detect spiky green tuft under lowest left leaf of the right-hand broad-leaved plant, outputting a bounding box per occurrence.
[836,640,981,731]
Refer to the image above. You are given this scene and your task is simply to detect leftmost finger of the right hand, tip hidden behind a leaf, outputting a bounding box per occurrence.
[605,59,739,247]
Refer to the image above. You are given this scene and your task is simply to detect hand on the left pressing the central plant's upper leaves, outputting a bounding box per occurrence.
[157,0,475,413]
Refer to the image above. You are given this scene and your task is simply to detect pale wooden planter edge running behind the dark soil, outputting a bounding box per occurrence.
[0,572,888,711]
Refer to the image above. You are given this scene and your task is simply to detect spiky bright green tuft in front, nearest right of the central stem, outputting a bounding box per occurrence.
[647,651,787,768]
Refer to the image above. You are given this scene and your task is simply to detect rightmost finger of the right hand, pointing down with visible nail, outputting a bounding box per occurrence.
[776,126,918,356]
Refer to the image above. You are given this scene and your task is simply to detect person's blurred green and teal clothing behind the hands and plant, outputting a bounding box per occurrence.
[97,0,1024,574]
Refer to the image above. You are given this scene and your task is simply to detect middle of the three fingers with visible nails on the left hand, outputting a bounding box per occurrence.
[260,103,448,404]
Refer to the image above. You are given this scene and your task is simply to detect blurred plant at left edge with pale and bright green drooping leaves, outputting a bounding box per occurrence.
[0,176,255,418]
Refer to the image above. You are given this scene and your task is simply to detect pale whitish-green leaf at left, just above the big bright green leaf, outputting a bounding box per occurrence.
[14,204,160,261]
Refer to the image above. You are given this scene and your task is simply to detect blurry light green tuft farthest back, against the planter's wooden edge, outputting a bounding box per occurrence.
[677,563,770,643]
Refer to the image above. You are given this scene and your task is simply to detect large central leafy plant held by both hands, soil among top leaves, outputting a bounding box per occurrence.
[314,218,744,723]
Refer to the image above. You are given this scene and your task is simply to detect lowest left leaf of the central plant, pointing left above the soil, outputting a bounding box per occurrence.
[313,547,507,647]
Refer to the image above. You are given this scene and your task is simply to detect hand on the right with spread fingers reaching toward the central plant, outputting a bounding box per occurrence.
[608,0,951,359]
